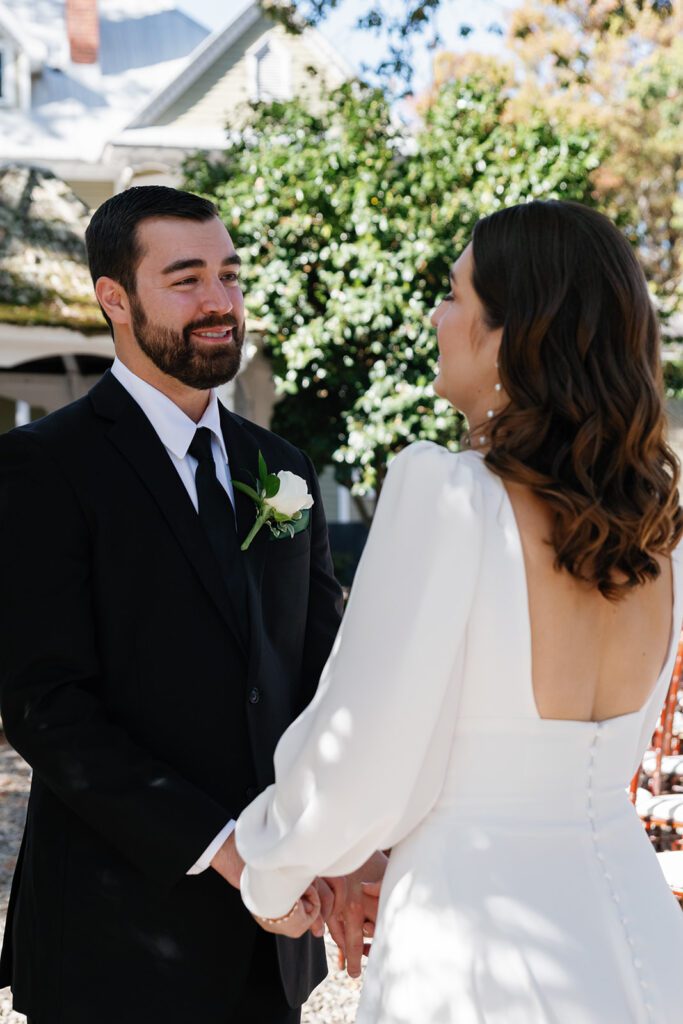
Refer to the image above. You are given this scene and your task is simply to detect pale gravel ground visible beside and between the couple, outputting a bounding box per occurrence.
[0,732,360,1024]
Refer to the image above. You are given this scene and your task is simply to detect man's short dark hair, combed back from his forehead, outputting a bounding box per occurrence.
[85,185,218,330]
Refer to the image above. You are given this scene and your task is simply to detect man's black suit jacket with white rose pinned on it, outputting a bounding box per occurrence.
[0,373,341,1024]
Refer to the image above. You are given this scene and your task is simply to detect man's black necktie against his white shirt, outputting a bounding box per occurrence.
[187,427,248,628]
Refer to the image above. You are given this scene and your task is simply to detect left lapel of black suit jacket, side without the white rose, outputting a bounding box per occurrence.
[90,372,247,653]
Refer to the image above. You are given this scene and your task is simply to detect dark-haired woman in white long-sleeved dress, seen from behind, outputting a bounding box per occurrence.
[232,202,683,1024]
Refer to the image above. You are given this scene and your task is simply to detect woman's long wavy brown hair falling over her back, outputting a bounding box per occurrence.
[472,200,683,600]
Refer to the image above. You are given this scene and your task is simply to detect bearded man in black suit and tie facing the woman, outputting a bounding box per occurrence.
[0,186,341,1024]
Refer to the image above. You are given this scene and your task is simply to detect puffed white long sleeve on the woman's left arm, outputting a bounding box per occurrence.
[236,442,482,918]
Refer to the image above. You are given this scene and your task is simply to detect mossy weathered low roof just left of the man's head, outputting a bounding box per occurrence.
[0,165,104,332]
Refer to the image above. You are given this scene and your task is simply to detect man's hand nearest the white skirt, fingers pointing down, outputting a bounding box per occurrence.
[325,850,388,978]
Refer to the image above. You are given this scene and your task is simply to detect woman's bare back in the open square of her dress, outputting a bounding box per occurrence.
[505,481,673,721]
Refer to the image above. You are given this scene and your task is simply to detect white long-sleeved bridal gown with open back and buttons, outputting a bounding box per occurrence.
[237,443,683,1024]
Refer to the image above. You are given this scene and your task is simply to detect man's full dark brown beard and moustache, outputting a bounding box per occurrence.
[130,295,245,391]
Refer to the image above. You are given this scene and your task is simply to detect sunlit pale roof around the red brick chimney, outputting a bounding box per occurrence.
[0,0,210,162]
